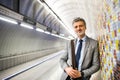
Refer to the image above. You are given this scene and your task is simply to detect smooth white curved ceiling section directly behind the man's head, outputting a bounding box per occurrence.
[44,0,102,37]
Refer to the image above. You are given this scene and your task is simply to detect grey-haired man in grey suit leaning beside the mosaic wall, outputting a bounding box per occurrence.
[60,17,100,80]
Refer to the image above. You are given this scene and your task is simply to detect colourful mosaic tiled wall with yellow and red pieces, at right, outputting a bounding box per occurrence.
[97,0,120,80]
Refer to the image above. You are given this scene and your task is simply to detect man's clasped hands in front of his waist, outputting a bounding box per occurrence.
[65,67,81,78]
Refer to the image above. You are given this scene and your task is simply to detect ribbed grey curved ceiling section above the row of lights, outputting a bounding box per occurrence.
[20,0,70,36]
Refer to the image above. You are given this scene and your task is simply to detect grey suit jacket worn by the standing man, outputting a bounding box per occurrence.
[60,37,100,80]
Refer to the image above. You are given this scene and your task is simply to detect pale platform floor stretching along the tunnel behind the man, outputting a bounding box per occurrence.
[0,51,102,80]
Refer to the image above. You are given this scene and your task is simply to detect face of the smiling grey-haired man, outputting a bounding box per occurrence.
[73,21,86,38]
